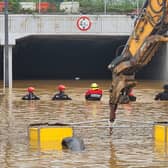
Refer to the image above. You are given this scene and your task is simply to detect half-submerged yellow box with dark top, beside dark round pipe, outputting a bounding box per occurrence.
[28,123,73,151]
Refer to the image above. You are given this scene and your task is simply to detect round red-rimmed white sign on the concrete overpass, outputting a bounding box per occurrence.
[77,16,92,31]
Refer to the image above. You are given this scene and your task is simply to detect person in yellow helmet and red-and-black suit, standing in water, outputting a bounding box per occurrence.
[85,83,103,100]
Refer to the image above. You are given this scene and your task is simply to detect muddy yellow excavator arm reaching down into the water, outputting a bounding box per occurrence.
[108,0,168,122]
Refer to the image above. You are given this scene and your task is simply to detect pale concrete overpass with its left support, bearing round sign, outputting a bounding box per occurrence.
[0,15,134,87]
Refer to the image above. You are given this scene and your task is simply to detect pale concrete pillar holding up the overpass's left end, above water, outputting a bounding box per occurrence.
[3,45,13,89]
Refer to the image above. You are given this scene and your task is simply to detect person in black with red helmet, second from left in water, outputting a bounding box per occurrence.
[52,85,72,100]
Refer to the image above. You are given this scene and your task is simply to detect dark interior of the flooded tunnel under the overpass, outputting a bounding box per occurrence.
[0,36,167,80]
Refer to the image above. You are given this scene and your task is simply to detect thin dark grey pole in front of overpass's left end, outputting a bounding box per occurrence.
[4,0,9,87]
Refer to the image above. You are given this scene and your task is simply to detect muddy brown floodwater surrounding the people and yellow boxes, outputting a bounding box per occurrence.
[0,80,168,168]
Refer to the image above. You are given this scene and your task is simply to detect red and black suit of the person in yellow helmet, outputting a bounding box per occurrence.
[85,89,102,100]
